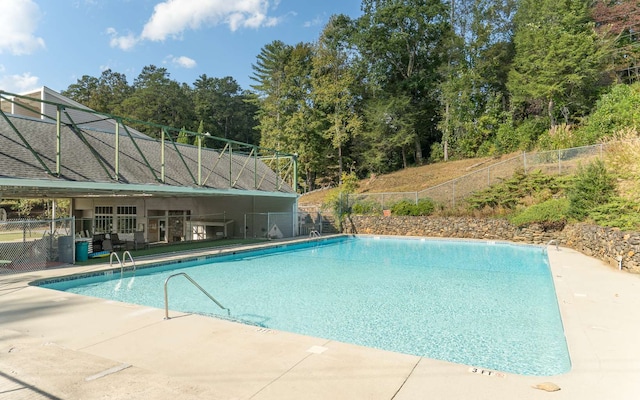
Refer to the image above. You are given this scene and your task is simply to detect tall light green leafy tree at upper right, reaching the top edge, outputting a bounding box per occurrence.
[507,0,606,127]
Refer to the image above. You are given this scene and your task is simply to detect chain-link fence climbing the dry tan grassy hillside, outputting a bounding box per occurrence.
[347,144,606,212]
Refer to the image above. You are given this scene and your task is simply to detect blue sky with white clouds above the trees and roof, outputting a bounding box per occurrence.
[0,0,361,93]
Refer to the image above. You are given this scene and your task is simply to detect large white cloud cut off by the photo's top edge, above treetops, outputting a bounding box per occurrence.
[140,0,280,41]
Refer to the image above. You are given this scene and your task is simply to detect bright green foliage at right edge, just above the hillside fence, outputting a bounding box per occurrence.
[576,83,640,145]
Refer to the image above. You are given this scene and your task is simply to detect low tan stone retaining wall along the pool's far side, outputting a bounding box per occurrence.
[343,215,640,273]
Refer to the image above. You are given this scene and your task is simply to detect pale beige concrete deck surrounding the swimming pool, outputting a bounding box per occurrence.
[0,242,640,400]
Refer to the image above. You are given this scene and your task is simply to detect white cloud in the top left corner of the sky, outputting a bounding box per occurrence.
[0,0,45,55]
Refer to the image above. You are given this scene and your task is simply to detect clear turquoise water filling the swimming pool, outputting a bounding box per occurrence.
[40,237,570,375]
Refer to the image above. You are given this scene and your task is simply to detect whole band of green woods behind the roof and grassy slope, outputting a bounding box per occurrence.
[64,0,640,191]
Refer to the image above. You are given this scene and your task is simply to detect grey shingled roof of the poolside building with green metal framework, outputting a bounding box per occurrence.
[0,115,295,197]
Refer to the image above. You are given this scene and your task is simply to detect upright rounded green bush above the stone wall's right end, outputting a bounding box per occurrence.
[567,160,616,220]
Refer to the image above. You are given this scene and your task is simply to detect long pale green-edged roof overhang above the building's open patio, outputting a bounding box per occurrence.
[0,177,298,199]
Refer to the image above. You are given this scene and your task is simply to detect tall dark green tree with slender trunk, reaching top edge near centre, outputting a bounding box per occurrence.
[353,0,448,164]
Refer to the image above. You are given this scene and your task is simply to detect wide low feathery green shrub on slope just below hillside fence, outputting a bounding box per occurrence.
[467,170,564,210]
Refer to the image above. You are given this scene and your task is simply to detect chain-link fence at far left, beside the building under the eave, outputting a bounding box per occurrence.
[0,218,75,274]
